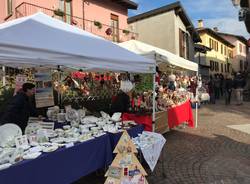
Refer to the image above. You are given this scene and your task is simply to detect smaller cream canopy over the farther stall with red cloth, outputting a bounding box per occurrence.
[119,40,198,72]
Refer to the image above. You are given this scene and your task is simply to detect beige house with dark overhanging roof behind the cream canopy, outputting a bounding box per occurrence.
[128,2,200,61]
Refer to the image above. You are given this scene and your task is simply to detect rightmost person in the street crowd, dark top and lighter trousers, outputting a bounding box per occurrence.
[234,73,246,105]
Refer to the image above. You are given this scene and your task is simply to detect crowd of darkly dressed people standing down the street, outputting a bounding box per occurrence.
[206,73,246,105]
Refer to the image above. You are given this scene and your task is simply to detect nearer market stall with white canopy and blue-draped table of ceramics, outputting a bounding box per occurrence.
[0,13,155,184]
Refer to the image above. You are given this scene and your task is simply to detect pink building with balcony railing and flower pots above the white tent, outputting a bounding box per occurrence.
[0,0,137,42]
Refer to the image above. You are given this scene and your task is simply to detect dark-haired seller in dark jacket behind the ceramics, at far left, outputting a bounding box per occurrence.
[0,83,35,132]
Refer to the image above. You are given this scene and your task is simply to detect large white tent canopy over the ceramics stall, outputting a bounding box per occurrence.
[0,12,155,73]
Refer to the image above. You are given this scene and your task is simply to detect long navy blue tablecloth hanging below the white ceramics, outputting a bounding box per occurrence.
[0,134,113,184]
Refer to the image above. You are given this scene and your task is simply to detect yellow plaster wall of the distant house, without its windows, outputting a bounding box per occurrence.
[200,33,233,75]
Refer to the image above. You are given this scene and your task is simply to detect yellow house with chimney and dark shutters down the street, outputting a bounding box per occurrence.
[197,20,234,76]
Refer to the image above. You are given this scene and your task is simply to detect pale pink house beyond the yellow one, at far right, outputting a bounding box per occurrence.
[219,33,248,73]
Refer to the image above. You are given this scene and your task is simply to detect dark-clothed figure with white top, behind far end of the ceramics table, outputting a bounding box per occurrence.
[111,81,134,114]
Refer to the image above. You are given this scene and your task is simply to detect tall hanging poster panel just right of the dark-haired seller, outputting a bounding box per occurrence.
[35,71,55,108]
